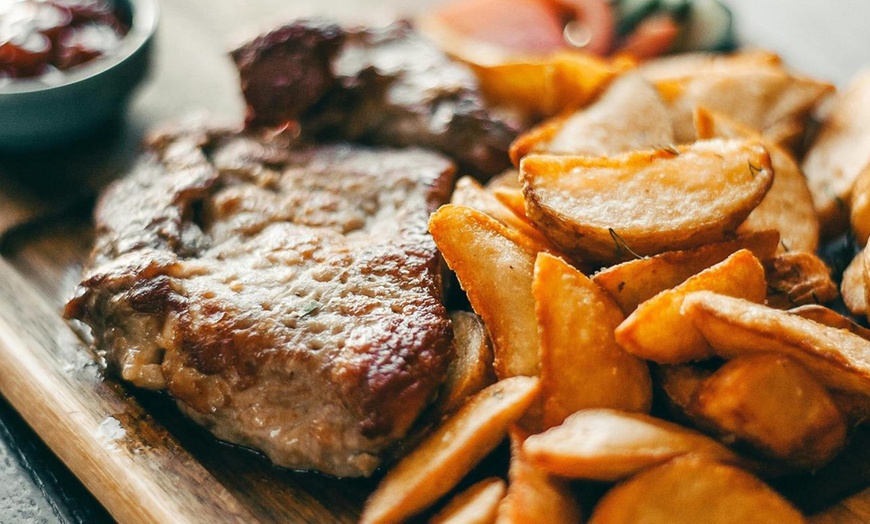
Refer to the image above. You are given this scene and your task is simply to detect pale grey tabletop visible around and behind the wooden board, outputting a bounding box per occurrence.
[0,0,870,523]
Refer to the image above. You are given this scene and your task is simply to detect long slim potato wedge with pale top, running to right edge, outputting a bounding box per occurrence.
[683,291,870,396]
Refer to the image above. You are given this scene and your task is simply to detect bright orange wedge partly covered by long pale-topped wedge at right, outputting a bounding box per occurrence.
[614,249,767,364]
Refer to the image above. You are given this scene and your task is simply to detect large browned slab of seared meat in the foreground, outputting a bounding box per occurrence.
[66,124,453,476]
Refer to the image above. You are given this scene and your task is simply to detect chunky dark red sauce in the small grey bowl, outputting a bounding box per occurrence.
[0,0,128,80]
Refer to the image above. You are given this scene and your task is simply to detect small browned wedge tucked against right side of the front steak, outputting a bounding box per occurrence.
[435,311,495,414]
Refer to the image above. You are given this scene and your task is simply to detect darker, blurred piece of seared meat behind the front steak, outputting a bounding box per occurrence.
[233,20,520,178]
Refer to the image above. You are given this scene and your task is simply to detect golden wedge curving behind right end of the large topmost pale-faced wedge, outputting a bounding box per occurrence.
[694,107,819,253]
